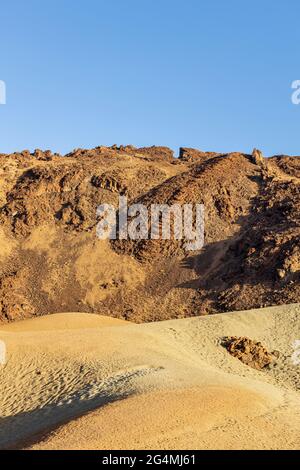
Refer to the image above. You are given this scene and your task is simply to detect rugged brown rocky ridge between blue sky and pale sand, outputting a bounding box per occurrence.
[0,145,300,321]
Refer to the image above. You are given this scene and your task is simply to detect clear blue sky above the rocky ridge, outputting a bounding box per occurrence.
[0,0,300,155]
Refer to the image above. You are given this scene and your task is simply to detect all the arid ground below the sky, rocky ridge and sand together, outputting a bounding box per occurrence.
[0,146,300,449]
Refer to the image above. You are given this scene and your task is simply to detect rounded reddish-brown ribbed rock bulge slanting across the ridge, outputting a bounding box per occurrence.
[113,153,257,261]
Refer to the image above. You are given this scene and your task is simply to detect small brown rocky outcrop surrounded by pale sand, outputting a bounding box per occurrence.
[224,336,276,370]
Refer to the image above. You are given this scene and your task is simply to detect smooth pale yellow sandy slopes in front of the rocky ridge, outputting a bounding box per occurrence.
[0,304,300,449]
